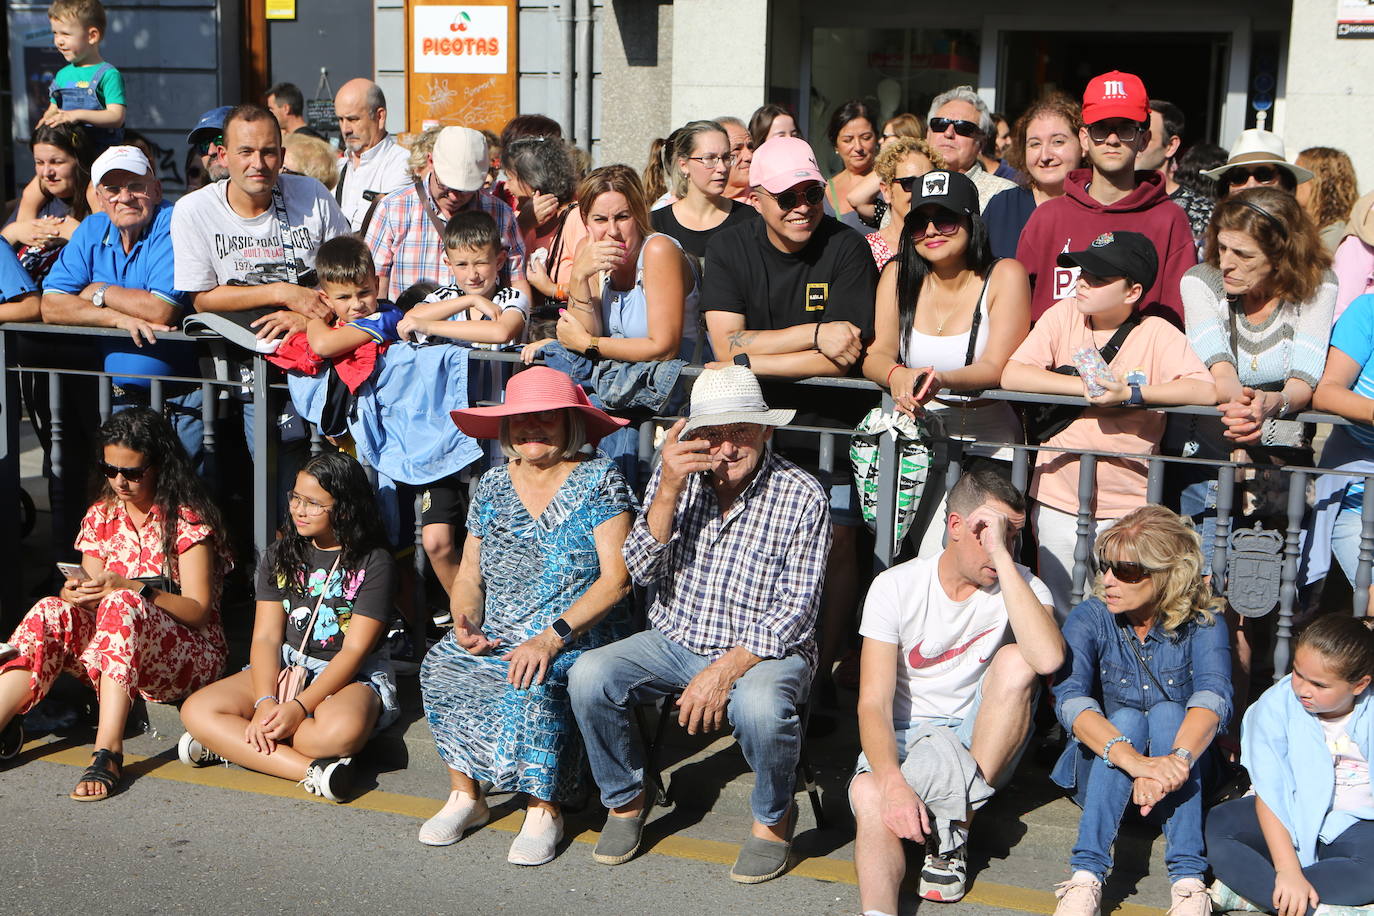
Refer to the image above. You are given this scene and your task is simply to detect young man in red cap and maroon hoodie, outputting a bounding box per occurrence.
[1017,70,1198,327]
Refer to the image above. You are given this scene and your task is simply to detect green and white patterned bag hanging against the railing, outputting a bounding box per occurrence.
[849,407,940,553]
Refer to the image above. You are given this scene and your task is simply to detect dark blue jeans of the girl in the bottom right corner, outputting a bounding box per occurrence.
[1206,797,1374,916]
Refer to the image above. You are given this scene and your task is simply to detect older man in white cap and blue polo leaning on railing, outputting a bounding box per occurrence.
[43,146,203,459]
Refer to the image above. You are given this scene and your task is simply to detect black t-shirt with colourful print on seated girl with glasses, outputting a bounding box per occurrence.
[257,545,396,658]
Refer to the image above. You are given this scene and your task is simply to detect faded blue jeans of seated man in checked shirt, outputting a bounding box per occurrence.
[567,630,811,824]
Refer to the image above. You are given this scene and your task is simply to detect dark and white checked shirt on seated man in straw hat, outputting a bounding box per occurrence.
[625,448,830,667]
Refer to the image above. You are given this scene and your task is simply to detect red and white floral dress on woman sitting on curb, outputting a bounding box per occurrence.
[0,500,229,713]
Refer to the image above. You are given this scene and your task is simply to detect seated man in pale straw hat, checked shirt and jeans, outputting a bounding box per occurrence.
[569,368,824,884]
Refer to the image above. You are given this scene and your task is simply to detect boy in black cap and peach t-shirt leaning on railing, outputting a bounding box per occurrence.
[1002,232,1216,623]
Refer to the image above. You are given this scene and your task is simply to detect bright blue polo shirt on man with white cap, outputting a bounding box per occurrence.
[43,201,199,387]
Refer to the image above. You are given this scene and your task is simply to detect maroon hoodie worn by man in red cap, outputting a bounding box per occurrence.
[1017,169,1198,327]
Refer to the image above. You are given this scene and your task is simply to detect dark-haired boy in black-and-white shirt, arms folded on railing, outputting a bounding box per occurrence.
[397,210,529,349]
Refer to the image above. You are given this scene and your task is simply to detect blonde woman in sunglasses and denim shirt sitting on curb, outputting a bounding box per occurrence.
[1051,505,1231,916]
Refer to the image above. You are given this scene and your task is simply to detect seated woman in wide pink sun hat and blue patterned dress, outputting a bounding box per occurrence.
[419,367,636,865]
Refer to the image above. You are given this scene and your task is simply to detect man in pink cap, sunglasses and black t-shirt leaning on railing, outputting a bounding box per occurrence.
[701,137,878,703]
